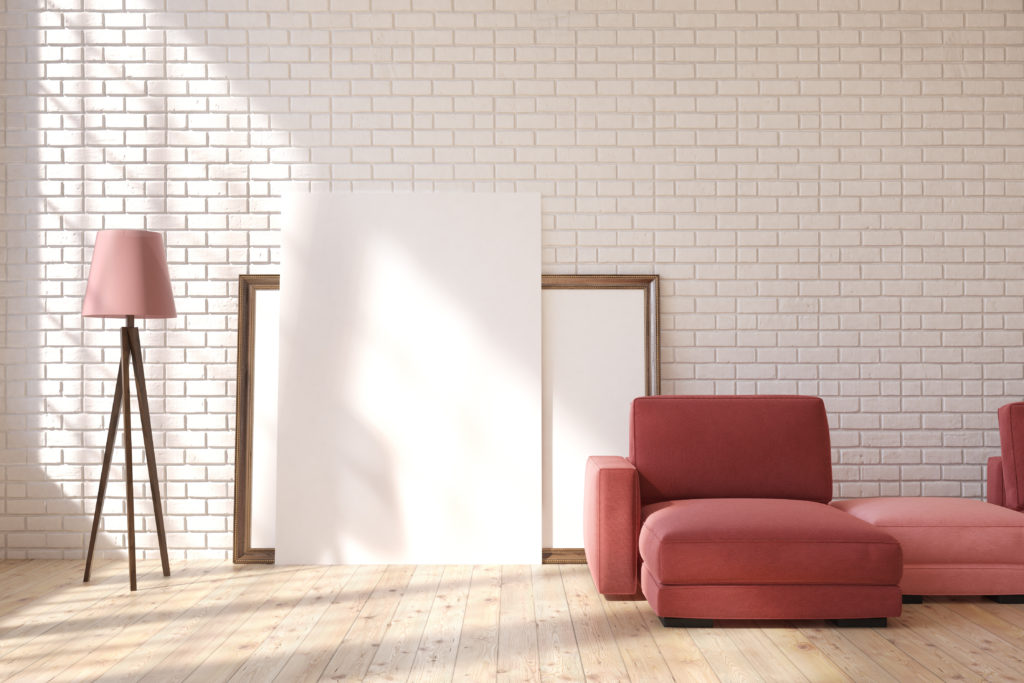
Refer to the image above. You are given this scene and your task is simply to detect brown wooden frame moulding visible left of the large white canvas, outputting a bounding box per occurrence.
[232,274,281,564]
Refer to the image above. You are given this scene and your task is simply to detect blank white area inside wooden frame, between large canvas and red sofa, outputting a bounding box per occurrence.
[543,288,646,548]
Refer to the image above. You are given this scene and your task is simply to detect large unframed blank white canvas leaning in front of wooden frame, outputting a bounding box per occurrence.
[276,193,541,564]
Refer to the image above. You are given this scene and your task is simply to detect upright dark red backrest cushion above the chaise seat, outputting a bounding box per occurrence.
[630,396,831,505]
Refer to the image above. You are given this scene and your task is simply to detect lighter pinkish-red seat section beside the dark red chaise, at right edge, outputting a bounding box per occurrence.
[833,497,1024,595]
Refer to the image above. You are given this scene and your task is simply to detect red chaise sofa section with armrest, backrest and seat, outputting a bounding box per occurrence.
[584,396,902,626]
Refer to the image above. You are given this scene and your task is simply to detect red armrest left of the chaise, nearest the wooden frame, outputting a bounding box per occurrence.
[583,456,640,595]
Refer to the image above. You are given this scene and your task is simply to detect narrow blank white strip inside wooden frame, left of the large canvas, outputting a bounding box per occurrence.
[249,289,281,548]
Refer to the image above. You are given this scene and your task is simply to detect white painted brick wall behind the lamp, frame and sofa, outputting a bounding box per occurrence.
[0,0,1024,558]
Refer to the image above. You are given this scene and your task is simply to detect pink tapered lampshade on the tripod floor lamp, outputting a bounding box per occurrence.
[82,230,177,317]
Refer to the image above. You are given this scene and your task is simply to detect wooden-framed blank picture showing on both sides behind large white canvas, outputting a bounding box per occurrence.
[233,264,659,563]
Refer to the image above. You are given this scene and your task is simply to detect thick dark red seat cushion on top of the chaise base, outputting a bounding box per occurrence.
[640,499,902,586]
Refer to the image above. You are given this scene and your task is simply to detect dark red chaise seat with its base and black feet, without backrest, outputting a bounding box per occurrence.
[640,498,901,626]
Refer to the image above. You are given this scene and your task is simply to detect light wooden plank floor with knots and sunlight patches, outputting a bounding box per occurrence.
[0,560,1024,682]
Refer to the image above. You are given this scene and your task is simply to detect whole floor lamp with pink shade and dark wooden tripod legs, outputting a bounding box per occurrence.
[82,230,176,591]
